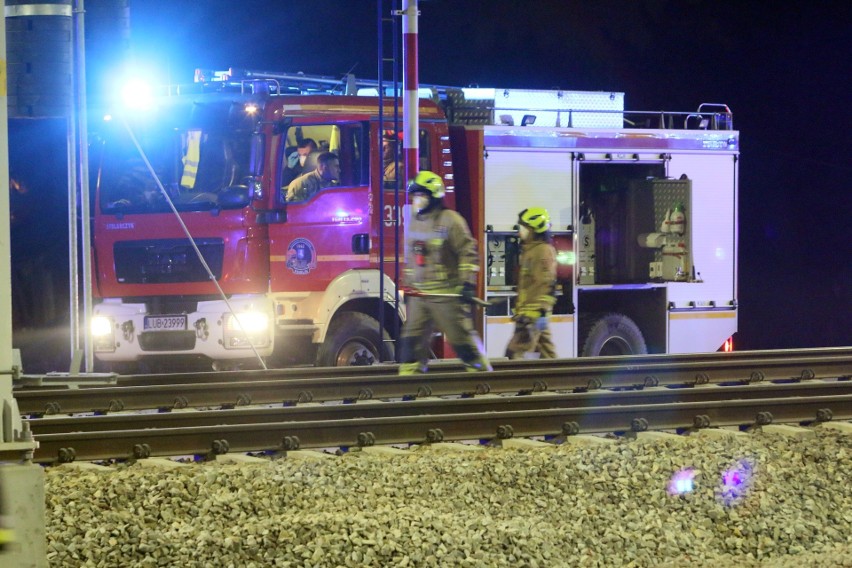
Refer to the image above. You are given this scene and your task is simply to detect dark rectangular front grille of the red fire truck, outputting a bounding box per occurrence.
[113,239,225,284]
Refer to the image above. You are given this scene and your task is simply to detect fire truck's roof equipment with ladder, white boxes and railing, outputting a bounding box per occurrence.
[195,69,733,130]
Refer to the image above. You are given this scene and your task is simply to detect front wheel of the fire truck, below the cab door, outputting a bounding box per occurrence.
[317,312,394,367]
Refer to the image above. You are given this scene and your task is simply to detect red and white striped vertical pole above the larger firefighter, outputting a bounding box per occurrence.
[402,0,420,180]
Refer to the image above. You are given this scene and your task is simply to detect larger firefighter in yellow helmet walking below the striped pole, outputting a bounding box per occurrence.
[399,171,491,375]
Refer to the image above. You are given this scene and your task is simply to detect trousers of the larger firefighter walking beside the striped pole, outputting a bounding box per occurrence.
[399,296,491,375]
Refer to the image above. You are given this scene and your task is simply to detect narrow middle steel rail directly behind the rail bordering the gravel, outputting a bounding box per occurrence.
[26,380,852,439]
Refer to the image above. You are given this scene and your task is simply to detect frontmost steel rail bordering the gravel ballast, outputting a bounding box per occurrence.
[34,395,852,463]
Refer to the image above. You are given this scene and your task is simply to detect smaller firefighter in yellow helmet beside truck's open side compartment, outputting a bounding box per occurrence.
[506,207,556,359]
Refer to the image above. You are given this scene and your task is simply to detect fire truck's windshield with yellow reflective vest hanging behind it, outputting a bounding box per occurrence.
[98,123,251,215]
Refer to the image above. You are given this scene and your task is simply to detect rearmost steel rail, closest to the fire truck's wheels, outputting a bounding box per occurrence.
[15,348,852,415]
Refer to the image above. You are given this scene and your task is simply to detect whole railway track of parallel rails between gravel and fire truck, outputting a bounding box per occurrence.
[15,349,852,463]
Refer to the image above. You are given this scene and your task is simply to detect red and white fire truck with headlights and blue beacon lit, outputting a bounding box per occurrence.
[90,71,739,370]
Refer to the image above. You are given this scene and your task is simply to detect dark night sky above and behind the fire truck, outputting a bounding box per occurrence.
[13,0,852,371]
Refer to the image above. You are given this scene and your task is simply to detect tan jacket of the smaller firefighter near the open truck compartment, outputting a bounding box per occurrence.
[515,240,556,318]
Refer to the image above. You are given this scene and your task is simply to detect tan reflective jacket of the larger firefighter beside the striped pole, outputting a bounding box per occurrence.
[403,207,479,294]
